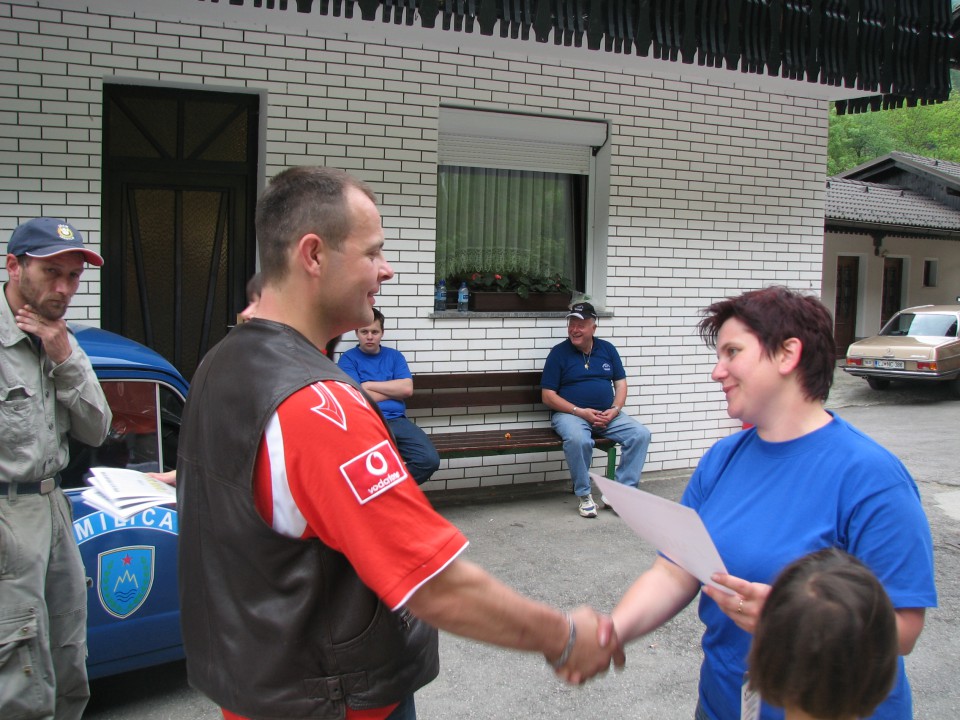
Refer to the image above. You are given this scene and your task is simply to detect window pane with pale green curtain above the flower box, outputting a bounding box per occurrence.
[436,165,586,287]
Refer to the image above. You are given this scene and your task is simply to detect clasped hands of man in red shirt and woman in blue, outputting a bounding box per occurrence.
[545,605,627,685]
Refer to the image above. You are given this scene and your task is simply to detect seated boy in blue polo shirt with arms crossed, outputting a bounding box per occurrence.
[337,308,440,485]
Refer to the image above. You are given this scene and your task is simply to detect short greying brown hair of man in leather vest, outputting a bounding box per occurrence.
[256,167,377,283]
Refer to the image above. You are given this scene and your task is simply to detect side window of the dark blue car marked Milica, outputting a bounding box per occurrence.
[61,380,183,487]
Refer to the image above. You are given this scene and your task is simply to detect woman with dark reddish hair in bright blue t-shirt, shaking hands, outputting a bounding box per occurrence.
[613,287,937,720]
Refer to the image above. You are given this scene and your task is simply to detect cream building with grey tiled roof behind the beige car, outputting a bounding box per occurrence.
[821,152,960,357]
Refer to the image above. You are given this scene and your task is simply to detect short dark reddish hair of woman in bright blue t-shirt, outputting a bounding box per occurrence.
[697,285,837,400]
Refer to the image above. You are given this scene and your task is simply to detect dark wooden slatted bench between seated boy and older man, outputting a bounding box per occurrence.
[406,371,617,479]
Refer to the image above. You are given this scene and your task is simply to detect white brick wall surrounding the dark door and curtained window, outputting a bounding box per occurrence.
[0,0,827,486]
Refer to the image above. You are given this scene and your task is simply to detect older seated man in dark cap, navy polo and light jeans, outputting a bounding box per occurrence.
[540,302,650,518]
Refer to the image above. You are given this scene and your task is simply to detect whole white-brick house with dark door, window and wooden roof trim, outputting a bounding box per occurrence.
[0,0,960,487]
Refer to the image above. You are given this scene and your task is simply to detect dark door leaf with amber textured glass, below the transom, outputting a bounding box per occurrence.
[109,173,249,378]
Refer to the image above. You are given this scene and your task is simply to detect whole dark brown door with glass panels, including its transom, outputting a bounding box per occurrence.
[102,85,259,379]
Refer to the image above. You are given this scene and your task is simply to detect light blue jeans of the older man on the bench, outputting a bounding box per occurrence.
[550,412,650,497]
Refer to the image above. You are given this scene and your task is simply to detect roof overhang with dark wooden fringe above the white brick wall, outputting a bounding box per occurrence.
[44,0,956,109]
